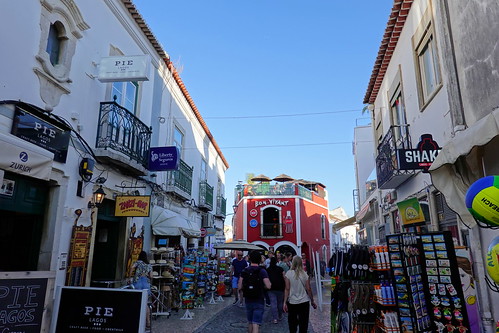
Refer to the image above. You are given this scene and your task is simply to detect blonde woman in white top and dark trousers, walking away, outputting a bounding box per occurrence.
[283,256,317,333]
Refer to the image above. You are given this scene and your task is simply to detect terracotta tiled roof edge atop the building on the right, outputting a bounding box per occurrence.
[364,0,414,104]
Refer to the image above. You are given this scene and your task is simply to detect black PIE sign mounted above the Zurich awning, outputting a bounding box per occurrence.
[11,106,71,163]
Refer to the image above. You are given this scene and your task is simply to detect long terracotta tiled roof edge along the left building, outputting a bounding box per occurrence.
[121,0,229,168]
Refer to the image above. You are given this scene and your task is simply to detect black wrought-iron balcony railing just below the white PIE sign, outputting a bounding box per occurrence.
[95,102,152,167]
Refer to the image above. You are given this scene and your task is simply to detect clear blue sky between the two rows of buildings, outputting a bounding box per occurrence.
[134,0,393,216]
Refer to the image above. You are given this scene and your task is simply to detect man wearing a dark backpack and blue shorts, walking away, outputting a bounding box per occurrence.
[238,250,271,333]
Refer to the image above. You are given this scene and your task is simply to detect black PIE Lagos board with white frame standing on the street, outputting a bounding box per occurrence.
[51,287,147,333]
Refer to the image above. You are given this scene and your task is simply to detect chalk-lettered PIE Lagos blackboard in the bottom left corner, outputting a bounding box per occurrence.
[0,279,47,333]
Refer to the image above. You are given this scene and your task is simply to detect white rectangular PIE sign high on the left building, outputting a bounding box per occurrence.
[99,55,150,82]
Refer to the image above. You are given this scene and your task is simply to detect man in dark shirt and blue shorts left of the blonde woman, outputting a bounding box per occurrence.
[239,250,271,333]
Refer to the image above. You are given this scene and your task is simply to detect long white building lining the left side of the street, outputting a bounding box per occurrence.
[0,0,228,329]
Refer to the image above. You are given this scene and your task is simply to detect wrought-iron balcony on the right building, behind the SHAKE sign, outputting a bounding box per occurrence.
[376,125,415,189]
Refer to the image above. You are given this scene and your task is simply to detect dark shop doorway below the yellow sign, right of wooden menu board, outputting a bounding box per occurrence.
[91,200,126,287]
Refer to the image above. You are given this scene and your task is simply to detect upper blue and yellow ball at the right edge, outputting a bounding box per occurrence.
[466,176,499,226]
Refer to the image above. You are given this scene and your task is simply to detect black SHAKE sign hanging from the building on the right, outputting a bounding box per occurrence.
[397,134,442,172]
